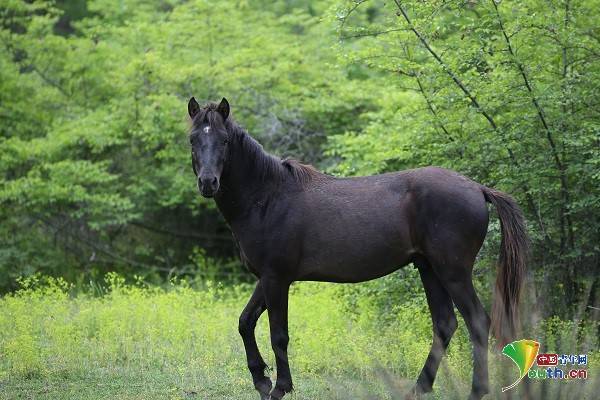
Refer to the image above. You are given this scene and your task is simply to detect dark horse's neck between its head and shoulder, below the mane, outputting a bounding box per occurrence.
[215,133,283,225]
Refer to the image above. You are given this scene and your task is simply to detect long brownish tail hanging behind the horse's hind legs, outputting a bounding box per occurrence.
[482,186,529,346]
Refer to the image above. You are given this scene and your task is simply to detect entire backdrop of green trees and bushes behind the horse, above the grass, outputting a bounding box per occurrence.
[0,0,600,315]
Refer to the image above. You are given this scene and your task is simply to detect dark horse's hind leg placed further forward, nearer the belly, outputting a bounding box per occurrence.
[408,258,458,398]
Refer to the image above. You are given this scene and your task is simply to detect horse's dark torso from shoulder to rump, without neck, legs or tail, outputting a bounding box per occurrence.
[236,167,487,282]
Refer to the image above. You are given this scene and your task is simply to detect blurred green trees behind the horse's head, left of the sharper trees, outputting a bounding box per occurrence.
[0,0,384,289]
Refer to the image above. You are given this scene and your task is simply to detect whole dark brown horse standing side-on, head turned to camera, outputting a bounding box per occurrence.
[188,98,527,400]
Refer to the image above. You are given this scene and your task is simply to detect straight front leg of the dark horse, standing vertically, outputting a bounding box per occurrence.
[261,277,293,400]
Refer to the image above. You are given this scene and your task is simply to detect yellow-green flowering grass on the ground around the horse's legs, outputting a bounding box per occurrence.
[0,276,598,400]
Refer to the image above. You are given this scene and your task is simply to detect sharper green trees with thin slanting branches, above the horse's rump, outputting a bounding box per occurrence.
[328,0,600,316]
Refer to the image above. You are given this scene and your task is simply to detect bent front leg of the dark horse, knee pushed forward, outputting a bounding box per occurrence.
[239,282,273,400]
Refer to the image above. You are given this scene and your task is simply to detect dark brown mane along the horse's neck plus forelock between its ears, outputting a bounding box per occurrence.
[192,102,325,186]
